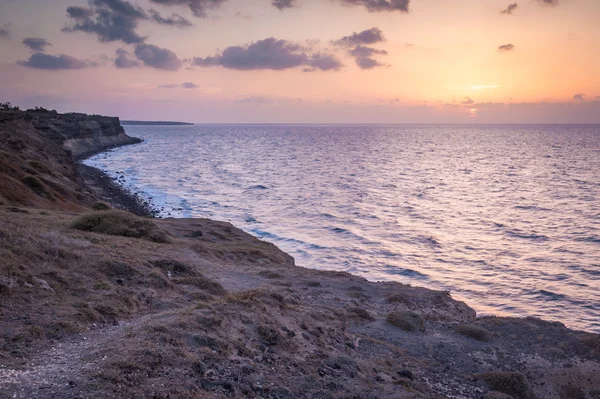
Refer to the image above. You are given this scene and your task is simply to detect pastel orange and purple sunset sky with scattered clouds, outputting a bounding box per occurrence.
[0,0,600,123]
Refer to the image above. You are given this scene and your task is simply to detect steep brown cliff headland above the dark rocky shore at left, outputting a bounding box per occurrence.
[0,110,141,210]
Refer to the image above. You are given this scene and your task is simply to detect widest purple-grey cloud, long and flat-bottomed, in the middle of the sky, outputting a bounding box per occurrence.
[193,37,341,71]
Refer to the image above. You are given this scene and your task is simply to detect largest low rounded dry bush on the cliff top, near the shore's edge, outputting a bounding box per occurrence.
[71,210,169,243]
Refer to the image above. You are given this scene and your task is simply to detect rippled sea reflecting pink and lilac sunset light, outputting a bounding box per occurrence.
[87,125,600,332]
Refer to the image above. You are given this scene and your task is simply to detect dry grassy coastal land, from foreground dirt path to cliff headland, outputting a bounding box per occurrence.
[0,110,600,399]
